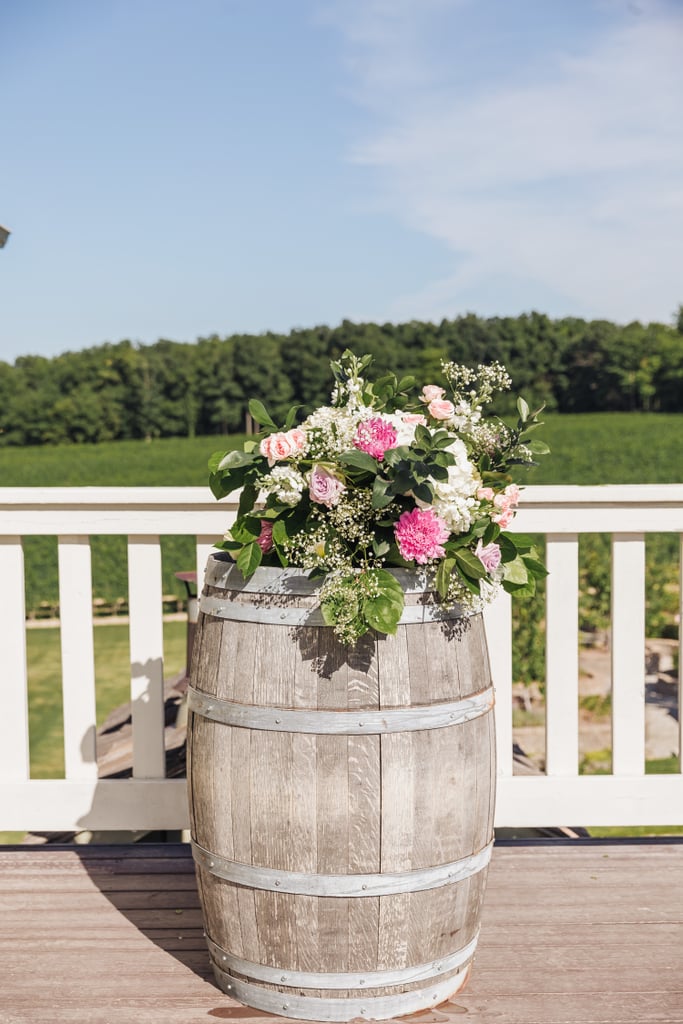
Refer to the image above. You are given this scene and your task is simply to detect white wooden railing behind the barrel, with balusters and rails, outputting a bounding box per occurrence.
[0,484,683,831]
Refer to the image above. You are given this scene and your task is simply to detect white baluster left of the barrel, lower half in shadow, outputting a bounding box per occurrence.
[128,536,166,778]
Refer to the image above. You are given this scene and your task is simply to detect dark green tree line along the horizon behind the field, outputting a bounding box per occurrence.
[0,306,683,445]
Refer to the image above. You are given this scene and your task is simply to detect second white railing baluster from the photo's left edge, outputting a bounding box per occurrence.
[57,537,97,779]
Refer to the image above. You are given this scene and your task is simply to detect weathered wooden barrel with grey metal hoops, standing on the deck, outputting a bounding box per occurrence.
[187,554,495,1021]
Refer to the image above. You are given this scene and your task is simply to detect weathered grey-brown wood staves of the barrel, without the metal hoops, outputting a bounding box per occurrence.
[189,568,493,1015]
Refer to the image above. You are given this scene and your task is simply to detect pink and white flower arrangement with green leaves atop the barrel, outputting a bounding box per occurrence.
[209,350,548,644]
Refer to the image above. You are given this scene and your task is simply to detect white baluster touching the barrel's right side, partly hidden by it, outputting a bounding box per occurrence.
[483,594,512,776]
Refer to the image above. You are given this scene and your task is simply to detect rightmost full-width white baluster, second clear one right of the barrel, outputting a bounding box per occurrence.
[611,534,645,775]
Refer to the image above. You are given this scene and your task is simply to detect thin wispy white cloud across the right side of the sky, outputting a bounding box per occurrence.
[327,0,683,321]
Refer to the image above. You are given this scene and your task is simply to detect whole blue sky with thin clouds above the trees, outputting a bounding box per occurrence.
[0,0,683,362]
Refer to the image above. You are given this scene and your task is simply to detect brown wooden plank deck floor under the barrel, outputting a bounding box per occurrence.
[0,841,683,1024]
